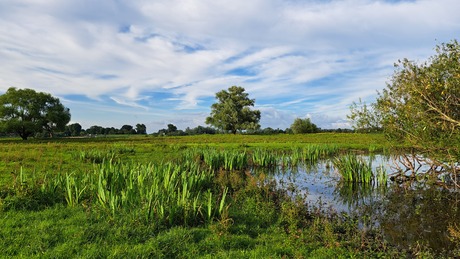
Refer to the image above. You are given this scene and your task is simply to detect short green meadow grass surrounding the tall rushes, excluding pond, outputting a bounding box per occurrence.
[0,134,450,258]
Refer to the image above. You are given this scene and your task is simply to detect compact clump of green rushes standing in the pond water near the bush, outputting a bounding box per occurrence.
[333,154,374,184]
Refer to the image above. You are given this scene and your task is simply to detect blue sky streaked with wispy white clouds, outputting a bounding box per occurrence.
[0,0,460,133]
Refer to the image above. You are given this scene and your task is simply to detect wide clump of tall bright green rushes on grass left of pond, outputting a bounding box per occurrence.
[50,160,228,226]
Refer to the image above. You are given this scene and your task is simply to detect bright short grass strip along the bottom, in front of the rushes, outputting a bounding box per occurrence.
[0,206,391,258]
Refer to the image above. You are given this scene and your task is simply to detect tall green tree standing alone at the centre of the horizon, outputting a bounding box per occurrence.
[206,86,260,134]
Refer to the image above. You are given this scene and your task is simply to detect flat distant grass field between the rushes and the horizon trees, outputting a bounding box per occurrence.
[0,133,389,181]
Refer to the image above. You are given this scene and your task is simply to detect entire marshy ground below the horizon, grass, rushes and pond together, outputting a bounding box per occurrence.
[0,133,460,258]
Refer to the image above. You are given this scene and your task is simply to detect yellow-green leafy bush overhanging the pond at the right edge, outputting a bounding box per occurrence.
[348,41,460,177]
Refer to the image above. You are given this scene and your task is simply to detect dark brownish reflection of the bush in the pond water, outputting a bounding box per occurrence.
[378,186,460,254]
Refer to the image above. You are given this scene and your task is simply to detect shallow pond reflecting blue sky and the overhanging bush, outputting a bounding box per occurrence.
[268,155,460,255]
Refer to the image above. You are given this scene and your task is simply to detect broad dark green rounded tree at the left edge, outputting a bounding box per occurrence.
[0,87,70,140]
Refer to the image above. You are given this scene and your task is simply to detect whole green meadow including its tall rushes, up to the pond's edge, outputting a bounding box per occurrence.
[0,133,460,258]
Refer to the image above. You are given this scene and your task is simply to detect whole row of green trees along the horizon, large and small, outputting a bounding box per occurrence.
[0,86,356,140]
